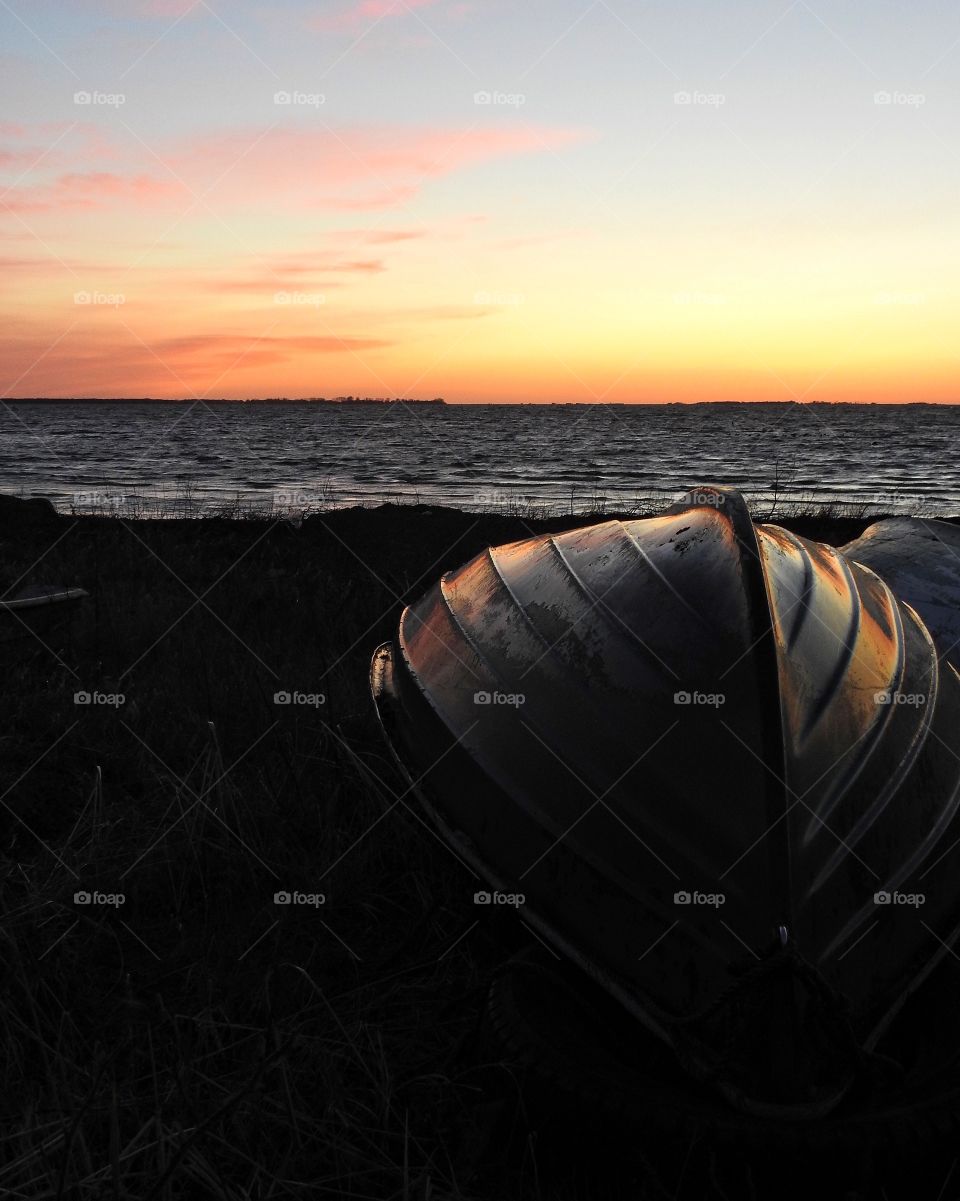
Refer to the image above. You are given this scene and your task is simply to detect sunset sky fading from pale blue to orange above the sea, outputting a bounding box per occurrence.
[0,0,960,402]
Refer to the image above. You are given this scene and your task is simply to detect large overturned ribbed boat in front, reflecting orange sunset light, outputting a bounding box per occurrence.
[371,486,960,1119]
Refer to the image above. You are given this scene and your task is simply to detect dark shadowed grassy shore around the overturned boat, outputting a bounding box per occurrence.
[0,501,960,1201]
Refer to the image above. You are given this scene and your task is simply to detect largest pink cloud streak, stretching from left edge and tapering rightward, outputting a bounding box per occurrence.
[0,125,583,220]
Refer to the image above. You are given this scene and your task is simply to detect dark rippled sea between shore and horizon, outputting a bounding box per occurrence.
[0,401,960,514]
